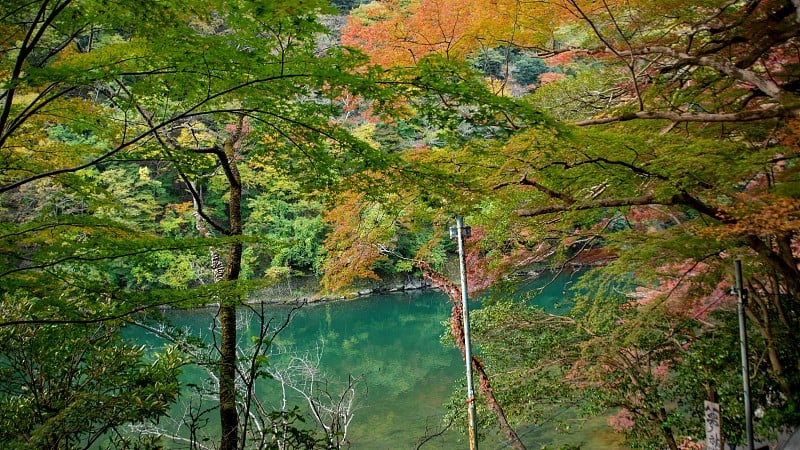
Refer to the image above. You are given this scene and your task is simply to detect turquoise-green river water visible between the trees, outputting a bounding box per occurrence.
[138,279,622,450]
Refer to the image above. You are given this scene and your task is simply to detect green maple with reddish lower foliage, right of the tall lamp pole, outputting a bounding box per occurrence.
[432,118,797,447]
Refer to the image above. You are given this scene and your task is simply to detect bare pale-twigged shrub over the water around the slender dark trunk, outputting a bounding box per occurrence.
[129,302,361,450]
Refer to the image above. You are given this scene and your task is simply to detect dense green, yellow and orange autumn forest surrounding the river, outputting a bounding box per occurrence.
[0,0,800,450]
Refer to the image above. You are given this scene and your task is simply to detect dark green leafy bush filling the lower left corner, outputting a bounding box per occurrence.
[0,297,186,449]
